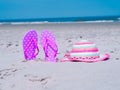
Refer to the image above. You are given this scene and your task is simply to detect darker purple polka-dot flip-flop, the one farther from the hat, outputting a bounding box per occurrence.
[23,30,39,60]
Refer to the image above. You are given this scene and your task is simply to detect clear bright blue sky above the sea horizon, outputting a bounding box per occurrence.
[0,0,120,19]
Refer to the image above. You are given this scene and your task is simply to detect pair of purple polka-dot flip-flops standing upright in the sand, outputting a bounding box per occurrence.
[23,30,58,62]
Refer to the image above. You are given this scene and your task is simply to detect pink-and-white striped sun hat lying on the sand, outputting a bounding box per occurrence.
[61,40,110,62]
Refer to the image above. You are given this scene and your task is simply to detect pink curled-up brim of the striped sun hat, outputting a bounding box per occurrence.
[61,54,110,63]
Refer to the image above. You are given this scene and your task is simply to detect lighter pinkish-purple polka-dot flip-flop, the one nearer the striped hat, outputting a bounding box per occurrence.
[40,30,58,62]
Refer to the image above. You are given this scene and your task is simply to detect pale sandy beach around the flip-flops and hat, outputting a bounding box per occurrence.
[0,23,120,90]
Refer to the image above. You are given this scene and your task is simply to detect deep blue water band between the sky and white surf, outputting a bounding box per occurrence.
[0,15,120,22]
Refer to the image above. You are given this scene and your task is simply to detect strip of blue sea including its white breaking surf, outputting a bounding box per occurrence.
[0,16,120,24]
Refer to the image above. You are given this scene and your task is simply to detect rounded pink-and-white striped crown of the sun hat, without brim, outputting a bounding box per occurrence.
[70,40,99,58]
